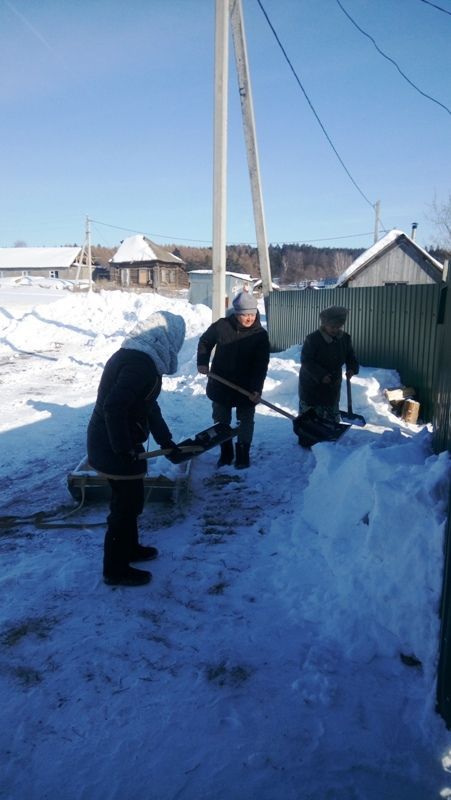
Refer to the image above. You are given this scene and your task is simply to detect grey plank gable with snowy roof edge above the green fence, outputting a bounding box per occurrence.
[336,229,443,288]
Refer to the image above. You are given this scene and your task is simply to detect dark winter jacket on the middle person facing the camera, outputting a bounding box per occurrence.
[197,312,269,408]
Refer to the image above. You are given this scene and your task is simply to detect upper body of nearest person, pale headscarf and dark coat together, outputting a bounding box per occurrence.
[87,312,185,477]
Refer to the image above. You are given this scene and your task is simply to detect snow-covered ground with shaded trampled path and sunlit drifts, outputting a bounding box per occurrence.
[0,289,451,800]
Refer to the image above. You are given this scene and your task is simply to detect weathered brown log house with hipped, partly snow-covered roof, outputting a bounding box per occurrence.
[110,234,188,291]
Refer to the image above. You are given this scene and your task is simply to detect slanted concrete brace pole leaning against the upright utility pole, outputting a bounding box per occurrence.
[229,0,272,296]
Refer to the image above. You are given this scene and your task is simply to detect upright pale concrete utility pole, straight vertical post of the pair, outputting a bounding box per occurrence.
[212,0,229,322]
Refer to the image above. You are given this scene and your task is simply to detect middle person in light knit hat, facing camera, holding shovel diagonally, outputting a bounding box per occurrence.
[197,291,269,469]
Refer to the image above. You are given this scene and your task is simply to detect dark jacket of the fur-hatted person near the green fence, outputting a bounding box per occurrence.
[299,328,359,406]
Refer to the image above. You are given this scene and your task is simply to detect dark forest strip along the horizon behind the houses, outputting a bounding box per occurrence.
[92,244,449,286]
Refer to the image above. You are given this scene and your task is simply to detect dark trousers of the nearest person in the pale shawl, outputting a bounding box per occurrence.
[103,478,144,576]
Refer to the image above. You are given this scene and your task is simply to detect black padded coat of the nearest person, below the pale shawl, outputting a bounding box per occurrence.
[88,349,172,477]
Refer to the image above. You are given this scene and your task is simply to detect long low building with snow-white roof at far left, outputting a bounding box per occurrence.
[0,247,82,280]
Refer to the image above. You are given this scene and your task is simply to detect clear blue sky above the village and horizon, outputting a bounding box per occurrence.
[0,0,451,247]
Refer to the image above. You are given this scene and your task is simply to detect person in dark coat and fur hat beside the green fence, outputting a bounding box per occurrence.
[299,306,359,422]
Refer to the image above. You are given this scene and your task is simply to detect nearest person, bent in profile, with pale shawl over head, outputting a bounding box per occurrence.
[87,311,185,586]
